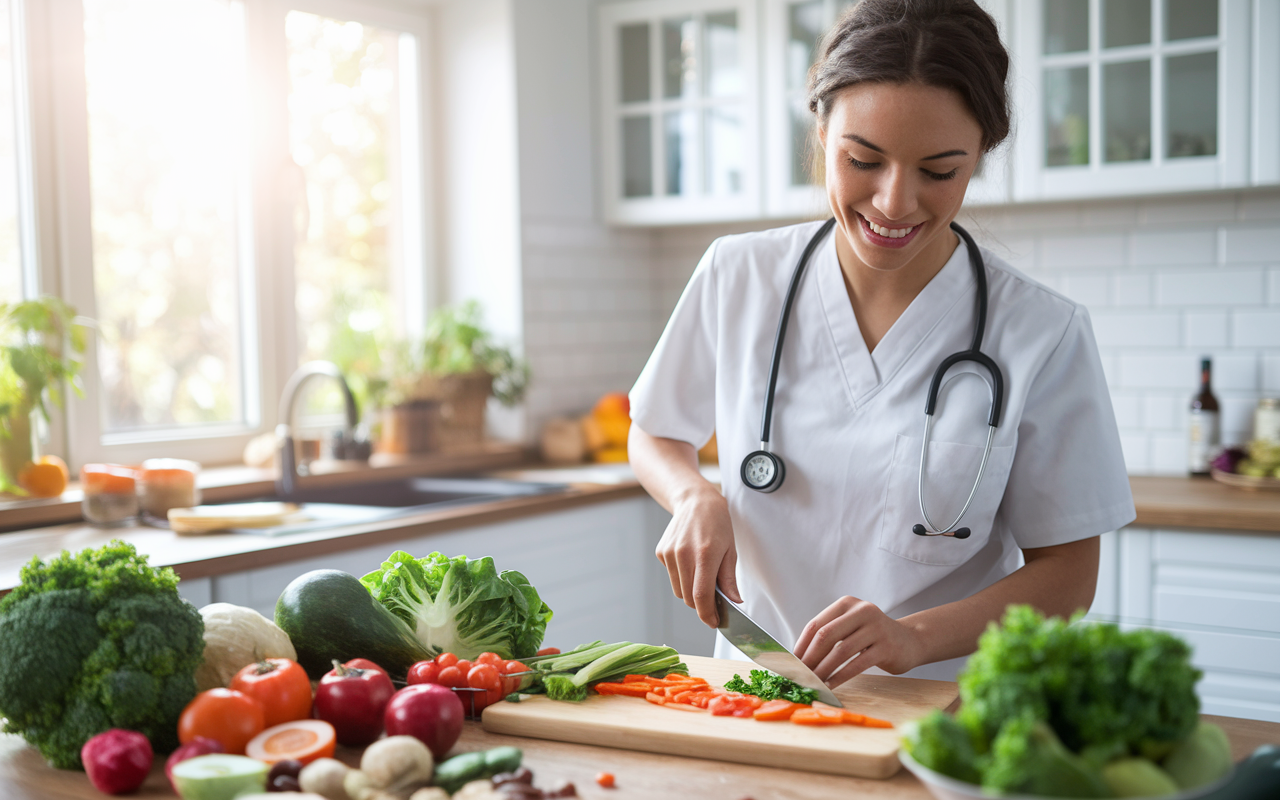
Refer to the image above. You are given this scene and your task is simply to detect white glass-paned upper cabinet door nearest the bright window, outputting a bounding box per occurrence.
[602,0,758,221]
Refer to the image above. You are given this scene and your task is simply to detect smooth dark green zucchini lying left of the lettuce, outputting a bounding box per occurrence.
[275,570,431,680]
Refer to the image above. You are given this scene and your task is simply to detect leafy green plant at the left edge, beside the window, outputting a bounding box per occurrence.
[0,296,88,494]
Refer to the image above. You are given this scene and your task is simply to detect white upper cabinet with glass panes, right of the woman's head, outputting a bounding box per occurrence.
[1011,0,1264,200]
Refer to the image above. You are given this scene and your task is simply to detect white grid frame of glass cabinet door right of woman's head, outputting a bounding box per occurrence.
[1012,0,1254,201]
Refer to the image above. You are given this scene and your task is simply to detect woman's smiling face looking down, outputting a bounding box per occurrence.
[818,83,982,276]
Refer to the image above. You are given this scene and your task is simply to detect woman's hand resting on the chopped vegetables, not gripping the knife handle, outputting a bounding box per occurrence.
[796,596,924,686]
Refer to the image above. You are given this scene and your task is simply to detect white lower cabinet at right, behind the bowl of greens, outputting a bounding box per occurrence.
[1091,527,1280,722]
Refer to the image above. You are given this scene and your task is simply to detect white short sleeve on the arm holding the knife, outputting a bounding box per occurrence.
[631,241,719,448]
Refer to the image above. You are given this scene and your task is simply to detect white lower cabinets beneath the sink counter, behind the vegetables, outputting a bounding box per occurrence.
[179,497,714,655]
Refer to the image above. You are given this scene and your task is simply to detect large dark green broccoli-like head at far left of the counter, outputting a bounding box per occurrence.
[0,541,205,769]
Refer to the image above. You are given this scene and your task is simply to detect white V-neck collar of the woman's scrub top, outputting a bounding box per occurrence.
[813,229,975,408]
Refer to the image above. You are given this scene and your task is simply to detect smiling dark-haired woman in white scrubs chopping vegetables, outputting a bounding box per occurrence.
[630,0,1134,686]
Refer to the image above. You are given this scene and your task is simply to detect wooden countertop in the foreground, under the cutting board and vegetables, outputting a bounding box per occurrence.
[0,706,1280,800]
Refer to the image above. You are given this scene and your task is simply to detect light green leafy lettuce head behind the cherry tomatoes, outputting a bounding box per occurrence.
[360,550,552,659]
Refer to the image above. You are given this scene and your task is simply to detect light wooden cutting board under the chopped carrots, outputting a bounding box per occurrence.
[481,655,956,778]
